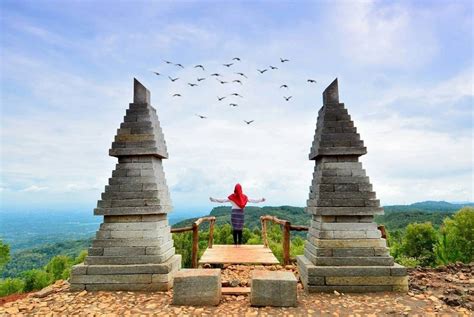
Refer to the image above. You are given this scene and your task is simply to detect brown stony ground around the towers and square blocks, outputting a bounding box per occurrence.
[0,264,474,316]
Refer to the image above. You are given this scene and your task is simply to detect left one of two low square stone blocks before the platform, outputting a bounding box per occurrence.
[173,269,222,306]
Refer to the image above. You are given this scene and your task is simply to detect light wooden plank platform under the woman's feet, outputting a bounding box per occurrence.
[199,244,280,264]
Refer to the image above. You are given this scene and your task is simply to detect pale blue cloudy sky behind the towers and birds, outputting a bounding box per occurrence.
[0,1,474,213]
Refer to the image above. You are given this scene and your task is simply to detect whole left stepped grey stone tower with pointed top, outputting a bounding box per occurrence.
[70,79,181,291]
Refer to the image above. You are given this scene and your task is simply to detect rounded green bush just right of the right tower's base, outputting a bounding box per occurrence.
[401,222,438,266]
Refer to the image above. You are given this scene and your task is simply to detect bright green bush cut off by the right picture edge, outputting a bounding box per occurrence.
[435,207,474,264]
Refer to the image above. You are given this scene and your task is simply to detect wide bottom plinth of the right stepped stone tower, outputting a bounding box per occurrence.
[296,255,408,293]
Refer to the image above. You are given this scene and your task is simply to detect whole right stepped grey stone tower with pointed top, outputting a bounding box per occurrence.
[297,79,408,292]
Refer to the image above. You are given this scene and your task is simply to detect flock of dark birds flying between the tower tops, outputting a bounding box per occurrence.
[153,57,317,125]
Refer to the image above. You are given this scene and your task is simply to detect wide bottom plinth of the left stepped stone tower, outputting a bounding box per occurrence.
[69,254,181,291]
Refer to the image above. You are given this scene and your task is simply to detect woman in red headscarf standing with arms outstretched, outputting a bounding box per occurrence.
[209,184,265,245]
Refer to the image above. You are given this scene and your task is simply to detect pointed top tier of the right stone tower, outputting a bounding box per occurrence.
[309,78,367,160]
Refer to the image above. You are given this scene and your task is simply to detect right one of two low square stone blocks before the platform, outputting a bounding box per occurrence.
[250,270,297,307]
